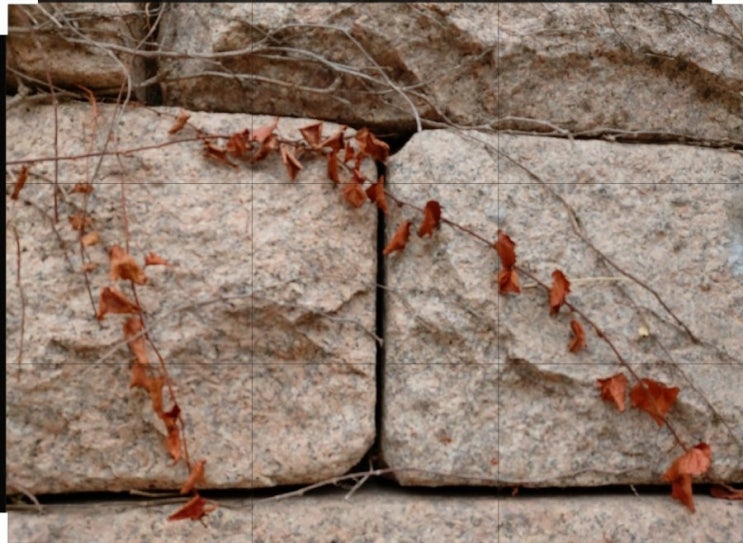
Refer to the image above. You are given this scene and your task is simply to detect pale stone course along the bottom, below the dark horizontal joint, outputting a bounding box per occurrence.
[8,489,743,543]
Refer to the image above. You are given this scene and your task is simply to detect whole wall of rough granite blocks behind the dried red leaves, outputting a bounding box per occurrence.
[6,3,743,541]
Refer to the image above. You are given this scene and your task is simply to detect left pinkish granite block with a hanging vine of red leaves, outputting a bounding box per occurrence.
[6,104,376,493]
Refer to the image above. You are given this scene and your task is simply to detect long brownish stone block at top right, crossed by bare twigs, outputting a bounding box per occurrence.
[155,3,743,142]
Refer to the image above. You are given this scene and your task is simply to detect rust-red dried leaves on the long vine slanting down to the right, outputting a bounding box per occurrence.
[189,113,728,512]
